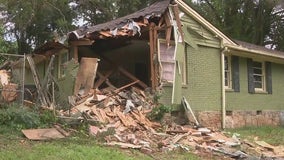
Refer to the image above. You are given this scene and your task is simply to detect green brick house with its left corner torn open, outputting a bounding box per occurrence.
[68,0,284,128]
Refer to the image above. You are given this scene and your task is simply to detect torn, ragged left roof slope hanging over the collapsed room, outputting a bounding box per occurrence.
[69,0,171,39]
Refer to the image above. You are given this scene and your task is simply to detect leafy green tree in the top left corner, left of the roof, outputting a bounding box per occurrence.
[0,0,75,54]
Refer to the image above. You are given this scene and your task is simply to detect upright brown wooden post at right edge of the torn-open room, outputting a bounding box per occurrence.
[149,23,155,89]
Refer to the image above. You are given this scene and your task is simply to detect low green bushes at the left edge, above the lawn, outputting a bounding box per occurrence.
[0,104,55,130]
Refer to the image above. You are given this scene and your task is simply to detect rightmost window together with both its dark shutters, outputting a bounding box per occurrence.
[247,59,272,94]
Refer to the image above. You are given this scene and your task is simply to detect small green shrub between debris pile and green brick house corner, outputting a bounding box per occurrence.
[149,104,172,121]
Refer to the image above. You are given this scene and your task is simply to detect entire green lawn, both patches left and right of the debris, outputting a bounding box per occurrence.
[0,122,284,160]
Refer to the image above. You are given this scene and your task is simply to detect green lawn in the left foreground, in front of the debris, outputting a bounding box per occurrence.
[0,126,200,160]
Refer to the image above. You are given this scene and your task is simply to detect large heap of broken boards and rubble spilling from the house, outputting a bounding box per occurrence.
[57,87,284,159]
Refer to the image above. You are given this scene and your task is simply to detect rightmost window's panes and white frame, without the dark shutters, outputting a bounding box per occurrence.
[252,61,265,91]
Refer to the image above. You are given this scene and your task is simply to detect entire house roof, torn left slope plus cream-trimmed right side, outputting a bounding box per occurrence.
[68,0,284,59]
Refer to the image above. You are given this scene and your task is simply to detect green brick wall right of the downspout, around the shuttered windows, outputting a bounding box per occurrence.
[226,58,284,110]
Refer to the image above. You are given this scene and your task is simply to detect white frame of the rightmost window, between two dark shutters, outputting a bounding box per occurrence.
[252,60,266,92]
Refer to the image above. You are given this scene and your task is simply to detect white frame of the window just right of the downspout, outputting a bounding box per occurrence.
[224,55,232,89]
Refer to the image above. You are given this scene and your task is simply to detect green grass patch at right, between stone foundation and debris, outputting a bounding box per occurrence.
[226,126,284,145]
